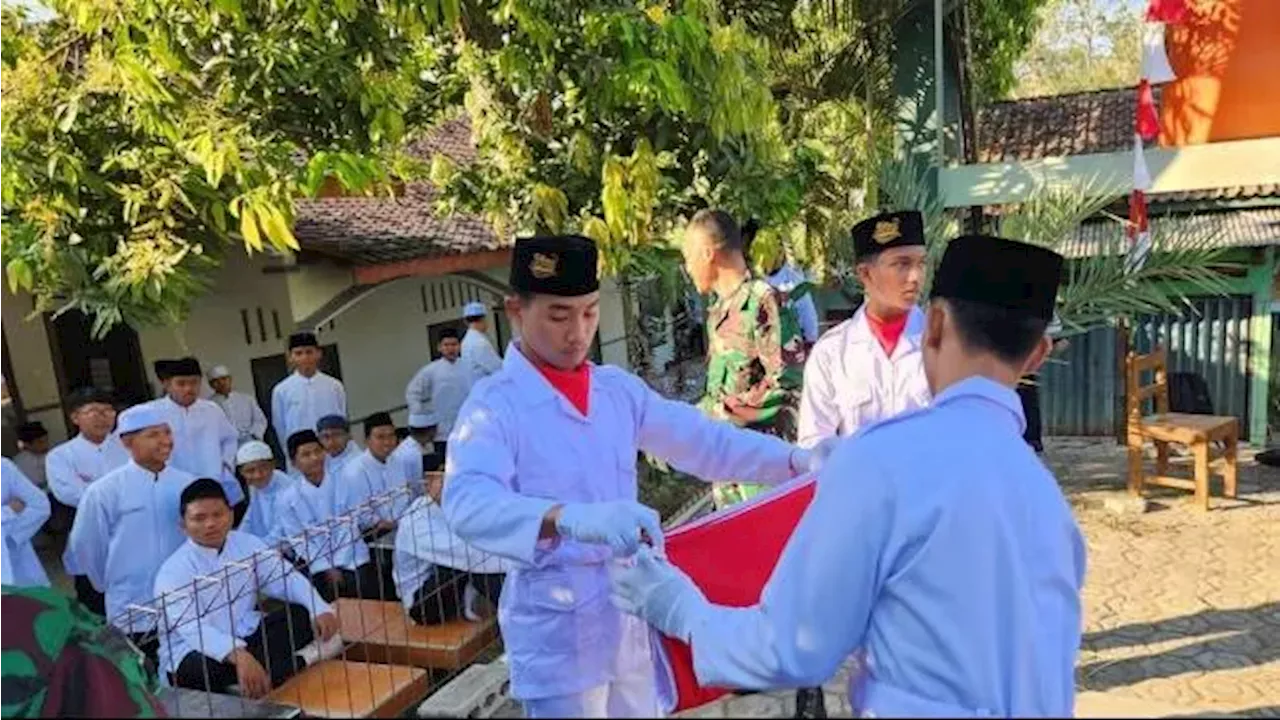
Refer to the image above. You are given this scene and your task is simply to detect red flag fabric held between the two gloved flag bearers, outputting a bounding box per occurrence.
[660,475,817,712]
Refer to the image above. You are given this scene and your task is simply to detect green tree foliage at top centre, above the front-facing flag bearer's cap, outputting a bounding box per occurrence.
[431,0,806,281]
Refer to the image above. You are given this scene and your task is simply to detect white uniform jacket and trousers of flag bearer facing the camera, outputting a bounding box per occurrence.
[444,345,792,700]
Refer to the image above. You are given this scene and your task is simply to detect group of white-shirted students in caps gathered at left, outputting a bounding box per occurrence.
[0,325,506,697]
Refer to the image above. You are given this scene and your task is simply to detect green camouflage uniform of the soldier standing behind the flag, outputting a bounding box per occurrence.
[698,278,805,507]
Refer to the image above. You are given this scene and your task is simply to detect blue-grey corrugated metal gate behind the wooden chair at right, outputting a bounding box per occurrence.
[1041,296,1254,436]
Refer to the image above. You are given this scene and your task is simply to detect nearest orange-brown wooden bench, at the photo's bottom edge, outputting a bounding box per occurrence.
[266,660,430,717]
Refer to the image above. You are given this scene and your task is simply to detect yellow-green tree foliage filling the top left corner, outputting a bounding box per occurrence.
[0,0,458,332]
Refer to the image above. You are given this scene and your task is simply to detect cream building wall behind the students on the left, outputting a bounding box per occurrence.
[0,252,640,441]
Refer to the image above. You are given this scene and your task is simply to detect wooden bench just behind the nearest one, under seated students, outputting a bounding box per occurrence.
[334,598,498,670]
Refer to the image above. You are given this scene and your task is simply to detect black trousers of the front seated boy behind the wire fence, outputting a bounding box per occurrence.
[169,603,314,693]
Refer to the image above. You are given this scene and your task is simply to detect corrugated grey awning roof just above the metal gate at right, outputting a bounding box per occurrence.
[1060,208,1280,258]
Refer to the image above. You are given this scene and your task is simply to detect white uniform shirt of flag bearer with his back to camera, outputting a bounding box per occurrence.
[691,378,1084,717]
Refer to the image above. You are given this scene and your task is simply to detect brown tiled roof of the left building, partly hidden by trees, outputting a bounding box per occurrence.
[293,115,501,265]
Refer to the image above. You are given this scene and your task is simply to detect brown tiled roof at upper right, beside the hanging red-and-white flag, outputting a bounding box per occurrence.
[975,87,1280,205]
